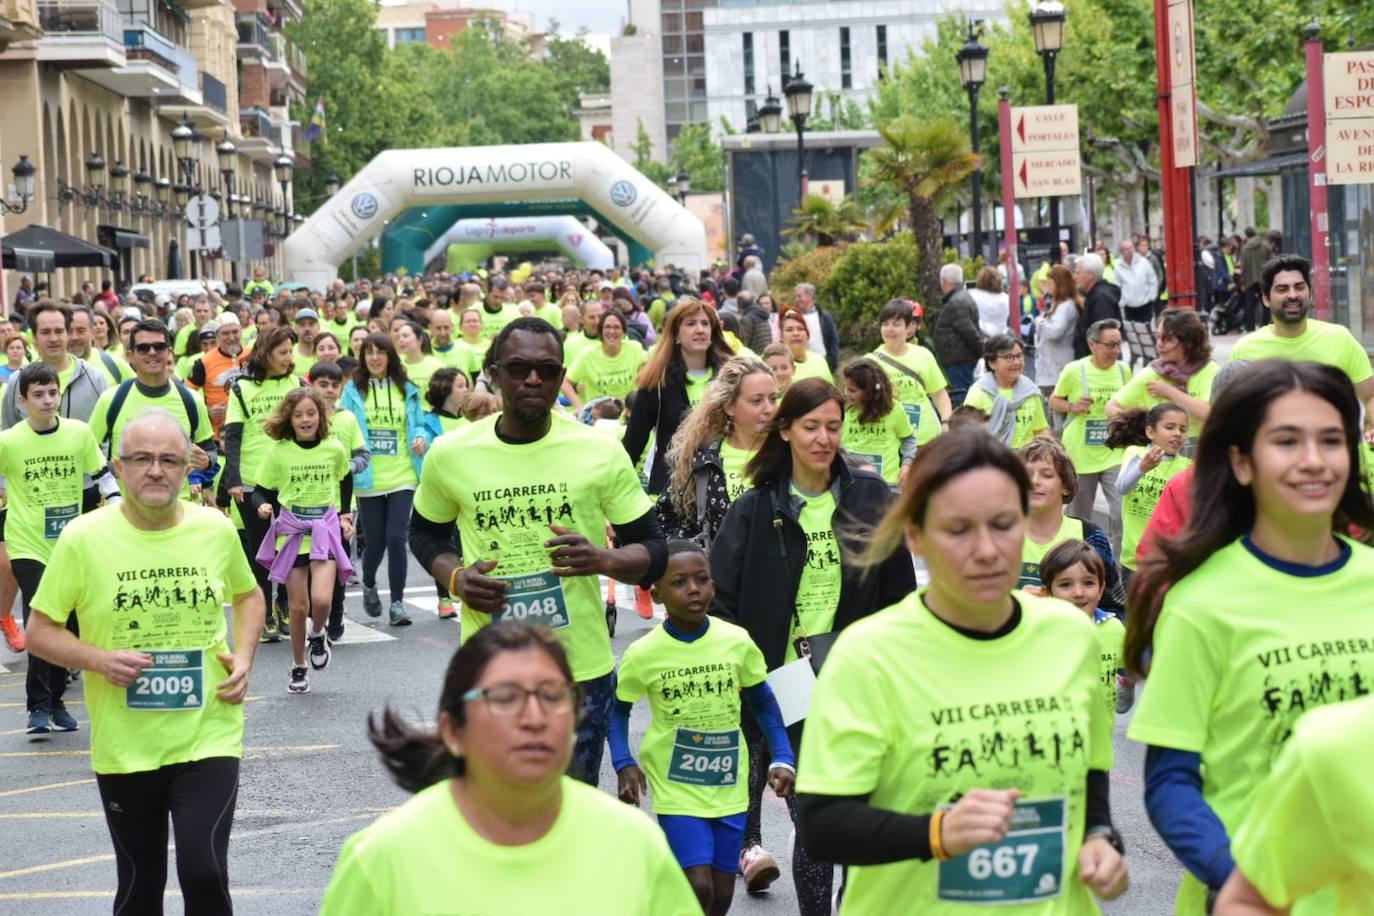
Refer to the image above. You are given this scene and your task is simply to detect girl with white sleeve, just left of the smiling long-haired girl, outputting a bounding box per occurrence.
[1107,401,1191,581]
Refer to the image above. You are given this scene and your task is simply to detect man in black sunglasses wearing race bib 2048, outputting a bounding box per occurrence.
[409,317,668,786]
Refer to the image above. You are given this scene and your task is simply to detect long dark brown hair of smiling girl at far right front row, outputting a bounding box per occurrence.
[1121,362,1374,673]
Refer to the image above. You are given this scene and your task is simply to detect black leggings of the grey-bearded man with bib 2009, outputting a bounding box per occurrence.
[95,758,239,916]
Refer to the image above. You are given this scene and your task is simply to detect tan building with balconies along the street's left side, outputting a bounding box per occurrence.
[0,0,309,300]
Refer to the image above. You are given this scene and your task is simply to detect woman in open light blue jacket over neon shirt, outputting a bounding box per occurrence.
[339,334,433,626]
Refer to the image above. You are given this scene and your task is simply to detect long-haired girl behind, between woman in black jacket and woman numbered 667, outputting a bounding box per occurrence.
[840,357,916,485]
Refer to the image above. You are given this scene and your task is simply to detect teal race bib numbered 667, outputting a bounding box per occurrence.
[938,798,1066,904]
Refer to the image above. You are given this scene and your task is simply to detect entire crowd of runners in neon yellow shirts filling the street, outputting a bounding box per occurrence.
[0,248,1374,916]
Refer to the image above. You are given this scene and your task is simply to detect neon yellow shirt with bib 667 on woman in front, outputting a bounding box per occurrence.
[797,589,1112,916]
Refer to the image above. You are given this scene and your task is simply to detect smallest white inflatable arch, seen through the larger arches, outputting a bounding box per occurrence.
[425,216,616,273]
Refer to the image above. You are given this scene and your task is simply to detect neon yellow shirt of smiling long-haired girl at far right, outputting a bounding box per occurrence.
[1126,538,1374,916]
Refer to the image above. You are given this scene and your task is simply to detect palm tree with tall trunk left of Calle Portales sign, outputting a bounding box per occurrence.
[867,114,981,302]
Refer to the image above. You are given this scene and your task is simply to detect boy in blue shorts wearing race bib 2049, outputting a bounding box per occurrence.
[610,540,797,916]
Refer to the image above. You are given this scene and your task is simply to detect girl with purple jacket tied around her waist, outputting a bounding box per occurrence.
[251,387,353,694]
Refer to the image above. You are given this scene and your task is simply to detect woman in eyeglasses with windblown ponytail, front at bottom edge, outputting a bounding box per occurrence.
[320,622,701,916]
